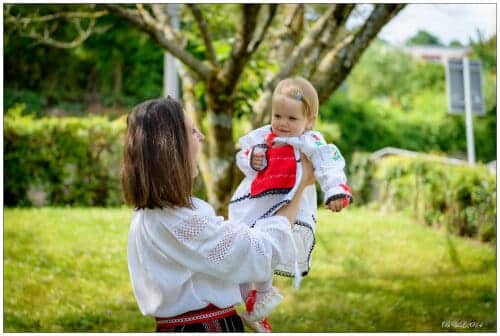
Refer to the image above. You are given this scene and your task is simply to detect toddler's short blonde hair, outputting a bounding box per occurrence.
[273,77,319,120]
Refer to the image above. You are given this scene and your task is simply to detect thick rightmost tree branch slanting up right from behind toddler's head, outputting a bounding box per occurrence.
[311,4,405,103]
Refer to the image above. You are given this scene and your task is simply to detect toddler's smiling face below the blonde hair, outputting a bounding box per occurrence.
[271,96,312,137]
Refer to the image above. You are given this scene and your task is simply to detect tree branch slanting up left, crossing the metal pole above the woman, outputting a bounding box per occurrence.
[103,3,215,80]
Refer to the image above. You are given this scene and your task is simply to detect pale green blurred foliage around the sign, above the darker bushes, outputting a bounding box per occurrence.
[346,36,496,116]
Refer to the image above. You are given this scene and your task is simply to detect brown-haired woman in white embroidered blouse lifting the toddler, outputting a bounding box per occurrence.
[122,97,314,332]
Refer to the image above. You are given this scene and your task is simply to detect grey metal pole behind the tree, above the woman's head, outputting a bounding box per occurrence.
[163,4,180,99]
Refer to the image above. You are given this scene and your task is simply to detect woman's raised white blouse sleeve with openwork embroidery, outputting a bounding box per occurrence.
[152,207,293,283]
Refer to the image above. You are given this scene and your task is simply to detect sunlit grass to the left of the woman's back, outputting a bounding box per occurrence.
[4,208,154,332]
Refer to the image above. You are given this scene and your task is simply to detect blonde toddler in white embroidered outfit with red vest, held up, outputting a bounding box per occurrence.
[229,77,352,332]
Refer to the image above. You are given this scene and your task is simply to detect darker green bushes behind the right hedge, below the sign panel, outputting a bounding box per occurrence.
[318,92,496,162]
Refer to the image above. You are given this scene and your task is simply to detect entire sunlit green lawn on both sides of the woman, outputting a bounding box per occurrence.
[3,208,496,332]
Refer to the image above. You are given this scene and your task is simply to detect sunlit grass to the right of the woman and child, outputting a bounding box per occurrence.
[271,209,496,332]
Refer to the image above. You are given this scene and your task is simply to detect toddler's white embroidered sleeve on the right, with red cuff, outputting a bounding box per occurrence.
[306,131,352,203]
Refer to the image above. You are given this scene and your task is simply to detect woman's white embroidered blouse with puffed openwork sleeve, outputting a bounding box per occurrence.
[128,198,296,317]
